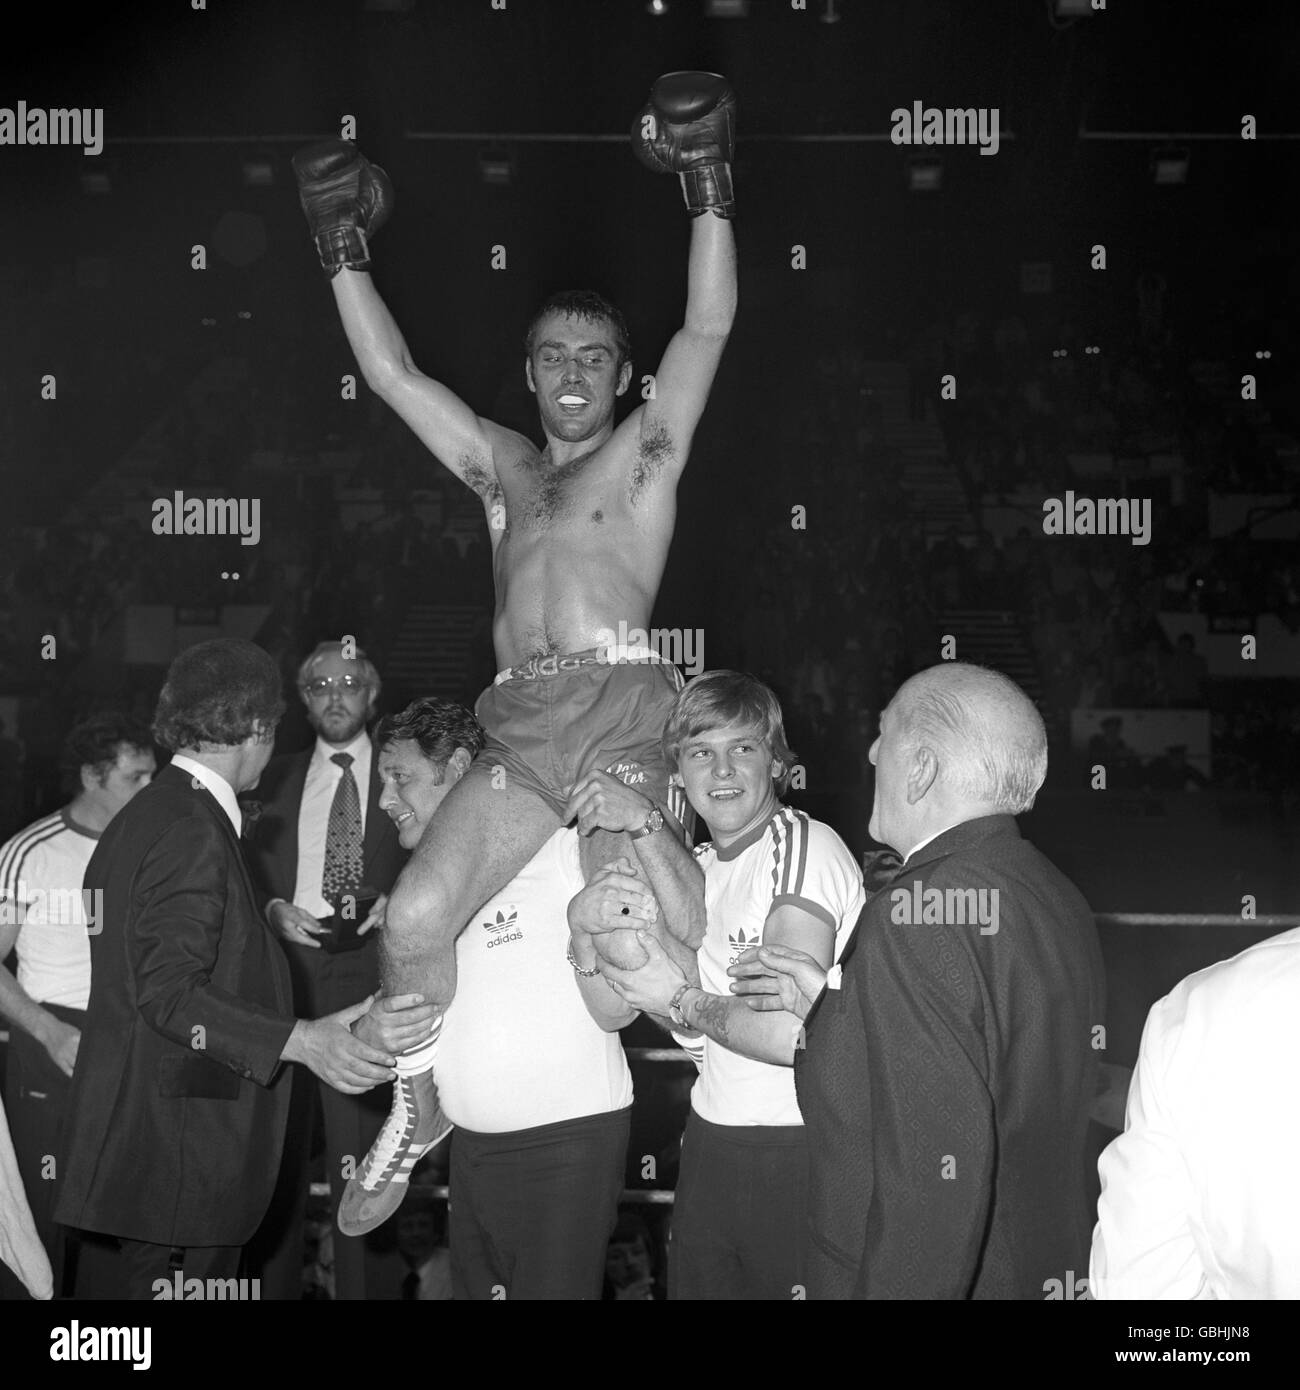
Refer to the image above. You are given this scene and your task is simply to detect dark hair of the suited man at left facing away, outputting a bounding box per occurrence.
[153,637,285,752]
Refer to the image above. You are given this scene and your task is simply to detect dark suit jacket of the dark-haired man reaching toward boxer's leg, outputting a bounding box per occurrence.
[56,767,293,1245]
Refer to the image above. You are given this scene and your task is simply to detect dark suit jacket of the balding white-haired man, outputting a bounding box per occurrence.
[795,816,1104,1300]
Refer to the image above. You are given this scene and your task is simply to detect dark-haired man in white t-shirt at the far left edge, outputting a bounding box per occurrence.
[0,713,154,1295]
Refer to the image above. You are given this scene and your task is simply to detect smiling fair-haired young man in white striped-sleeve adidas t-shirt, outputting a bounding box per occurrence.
[597,671,865,1300]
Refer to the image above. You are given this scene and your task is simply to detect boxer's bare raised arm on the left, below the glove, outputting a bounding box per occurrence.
[330,262,505,516]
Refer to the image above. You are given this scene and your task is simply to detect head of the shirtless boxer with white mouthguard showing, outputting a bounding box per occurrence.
[524,314,633,443]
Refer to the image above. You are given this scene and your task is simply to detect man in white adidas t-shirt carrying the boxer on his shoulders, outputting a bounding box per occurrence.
[375,698,692,1300]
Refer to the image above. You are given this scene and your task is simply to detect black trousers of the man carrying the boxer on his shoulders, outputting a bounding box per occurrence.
[449,1106,631,1300]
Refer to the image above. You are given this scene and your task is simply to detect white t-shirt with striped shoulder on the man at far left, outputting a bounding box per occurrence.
[0,808,103,1009]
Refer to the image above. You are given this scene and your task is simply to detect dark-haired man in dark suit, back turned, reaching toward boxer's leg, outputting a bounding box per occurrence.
[56,638,427,1298]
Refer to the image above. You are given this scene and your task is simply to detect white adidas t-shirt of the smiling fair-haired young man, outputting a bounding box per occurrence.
[679,806,866,1125]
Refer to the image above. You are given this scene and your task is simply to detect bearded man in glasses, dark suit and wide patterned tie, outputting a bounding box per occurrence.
[245,642,406,1298]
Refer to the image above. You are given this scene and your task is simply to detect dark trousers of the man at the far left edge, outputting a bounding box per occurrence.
[4,1004,86,1298]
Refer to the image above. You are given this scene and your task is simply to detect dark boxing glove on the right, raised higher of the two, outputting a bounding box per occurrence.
[633,72,736,217]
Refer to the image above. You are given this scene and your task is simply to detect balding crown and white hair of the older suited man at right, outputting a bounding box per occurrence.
[891,662,1047,816]
